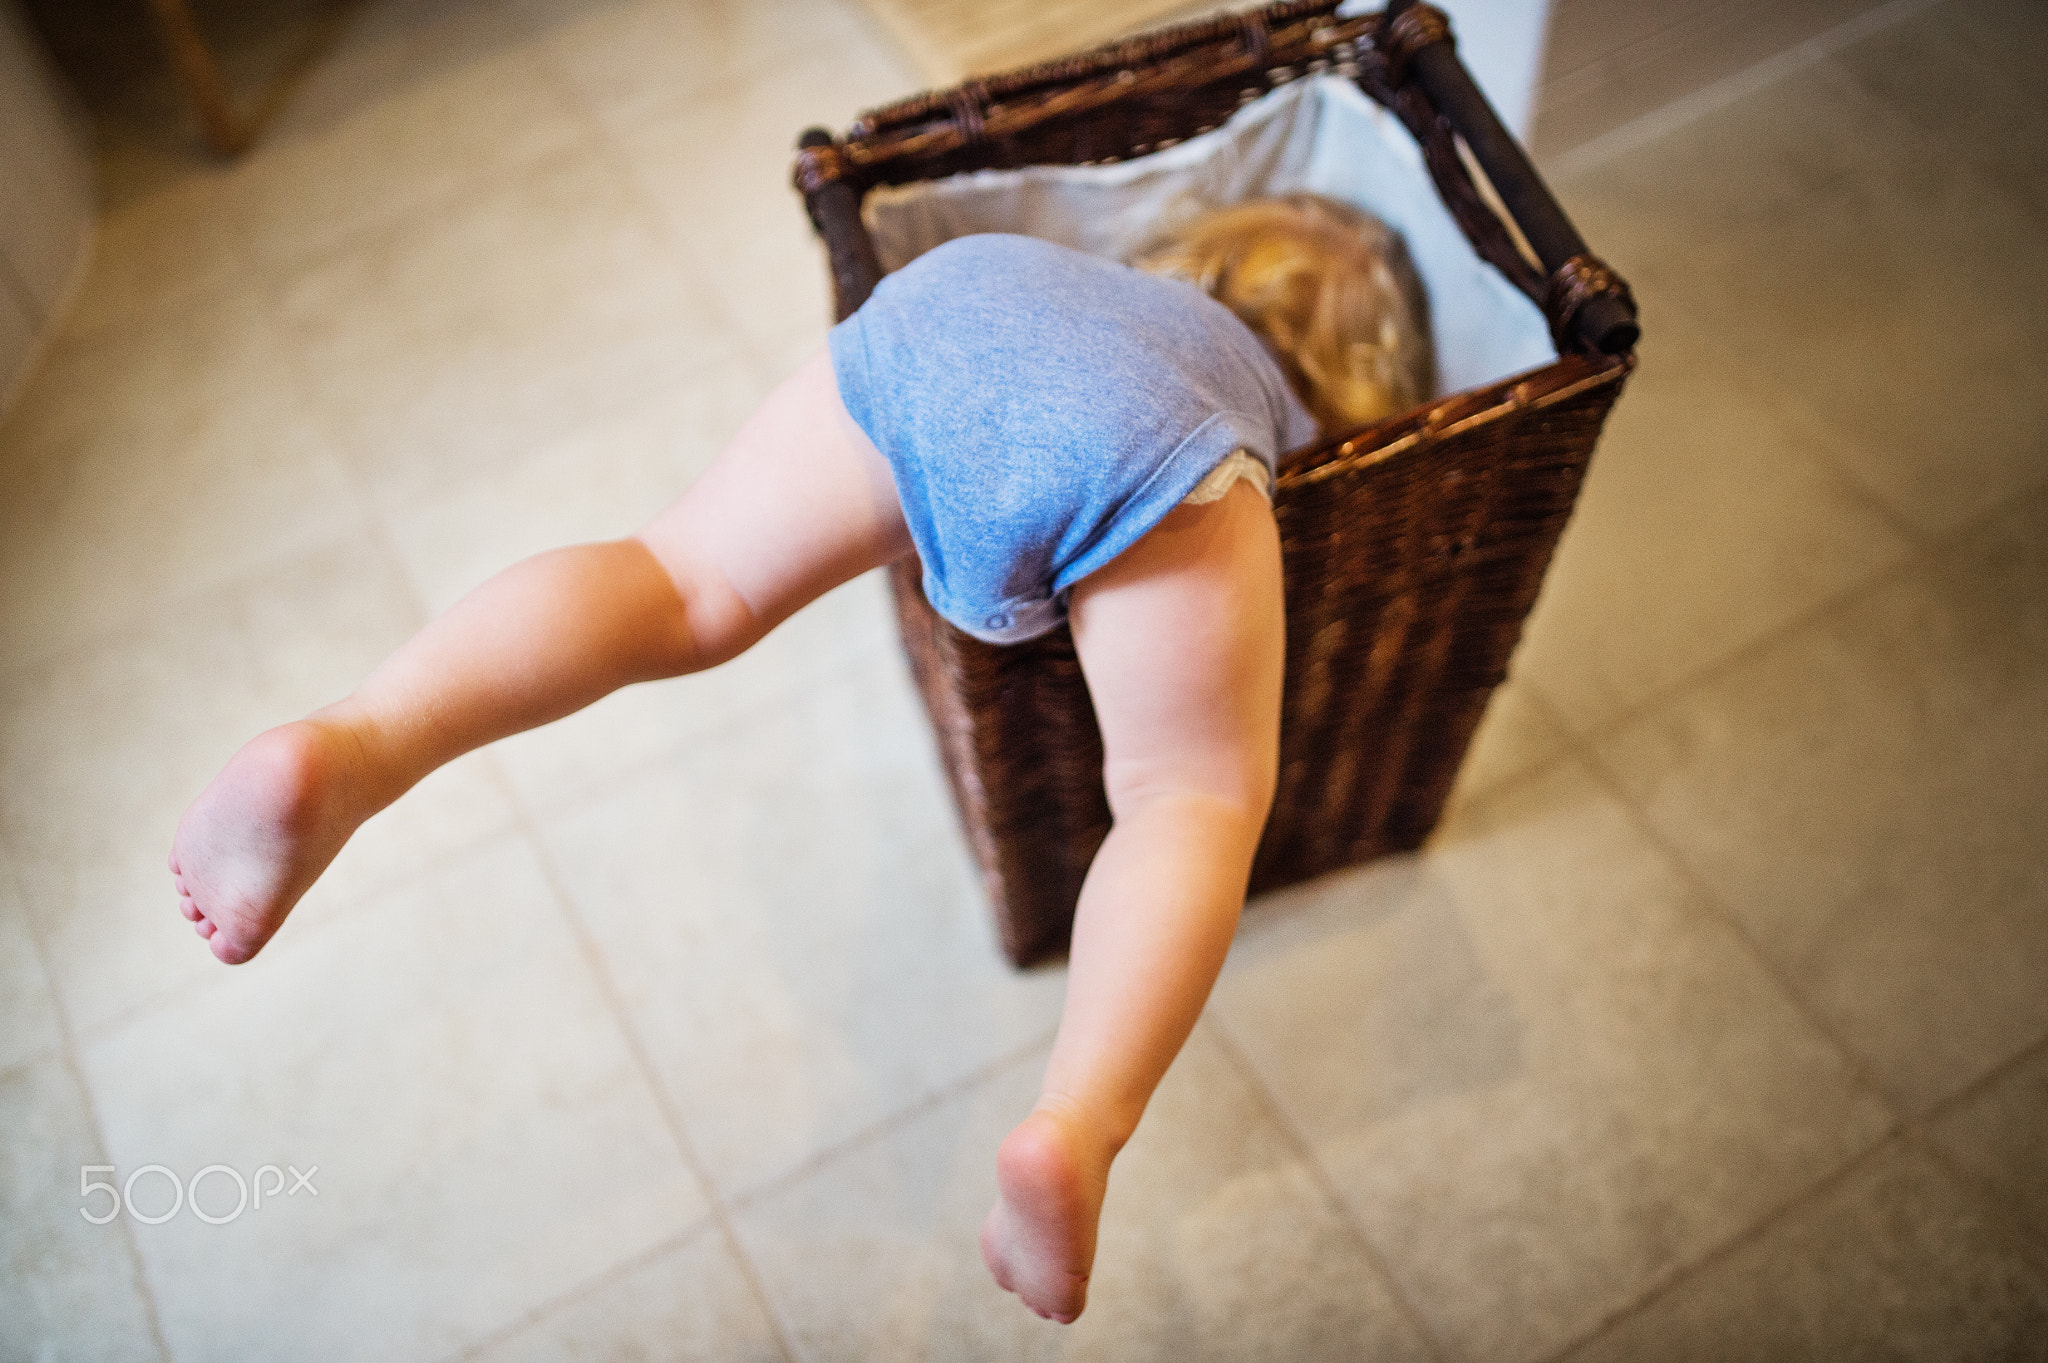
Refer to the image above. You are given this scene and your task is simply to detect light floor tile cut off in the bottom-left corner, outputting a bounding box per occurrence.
[0,1056,162,1363]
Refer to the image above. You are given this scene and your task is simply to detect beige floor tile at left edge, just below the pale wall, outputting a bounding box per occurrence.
[0,293,369,667]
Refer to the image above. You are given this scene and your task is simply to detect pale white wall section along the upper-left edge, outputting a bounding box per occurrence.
[0,0,94,409]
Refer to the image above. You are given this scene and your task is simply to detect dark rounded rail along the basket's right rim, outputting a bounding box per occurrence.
[1376,0,1642,354]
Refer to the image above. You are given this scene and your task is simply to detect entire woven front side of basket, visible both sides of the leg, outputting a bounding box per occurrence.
[891,356,1630,966]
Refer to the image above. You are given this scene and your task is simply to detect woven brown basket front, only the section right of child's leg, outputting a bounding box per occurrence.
[1251,356,1628,892]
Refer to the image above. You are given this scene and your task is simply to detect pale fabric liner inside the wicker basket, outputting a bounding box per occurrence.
[866,78,1556,393]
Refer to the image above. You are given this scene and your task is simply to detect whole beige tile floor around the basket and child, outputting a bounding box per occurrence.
[0,0,2048,1363]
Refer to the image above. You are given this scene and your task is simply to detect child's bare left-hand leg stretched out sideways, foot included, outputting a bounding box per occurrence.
[170,350,909,964]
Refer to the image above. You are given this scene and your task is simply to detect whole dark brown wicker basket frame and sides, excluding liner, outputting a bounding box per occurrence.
[797,0,1636,966]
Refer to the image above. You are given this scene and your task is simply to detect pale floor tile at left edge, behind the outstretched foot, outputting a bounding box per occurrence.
[0,542,514,1031]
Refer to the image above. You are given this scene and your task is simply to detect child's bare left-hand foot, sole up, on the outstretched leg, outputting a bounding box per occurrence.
[170,720,377,966]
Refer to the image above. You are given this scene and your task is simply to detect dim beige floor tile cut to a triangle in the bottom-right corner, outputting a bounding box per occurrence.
[1569,1144,2048,1363]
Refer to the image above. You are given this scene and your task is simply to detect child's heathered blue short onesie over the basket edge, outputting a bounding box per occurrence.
[831,235,1317,643]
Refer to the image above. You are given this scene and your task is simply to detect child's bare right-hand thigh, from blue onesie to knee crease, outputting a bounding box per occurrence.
[1071,483,1286,817]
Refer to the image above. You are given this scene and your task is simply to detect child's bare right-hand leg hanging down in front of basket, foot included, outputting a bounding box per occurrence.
[981,476,1284,1322]
